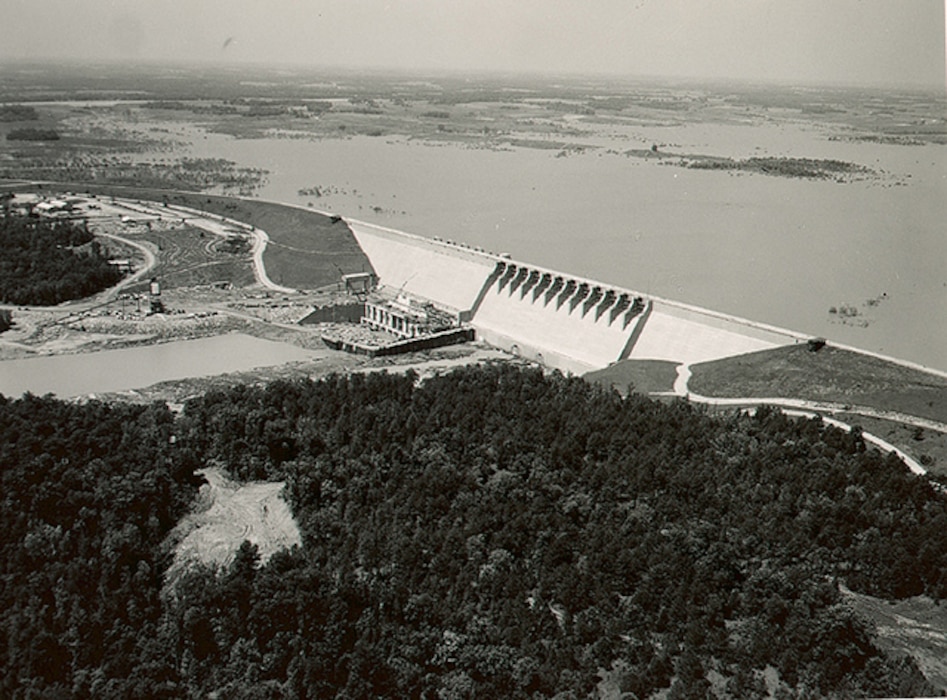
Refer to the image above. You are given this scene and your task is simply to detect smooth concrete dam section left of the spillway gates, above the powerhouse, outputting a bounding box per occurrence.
[346,219,495,311]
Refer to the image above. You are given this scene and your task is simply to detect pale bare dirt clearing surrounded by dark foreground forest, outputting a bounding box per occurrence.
[169,467,301,579]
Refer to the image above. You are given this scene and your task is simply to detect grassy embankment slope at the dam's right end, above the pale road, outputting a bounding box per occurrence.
[689,345,947,423]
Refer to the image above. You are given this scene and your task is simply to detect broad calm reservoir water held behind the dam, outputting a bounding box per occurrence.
[190,122,947,370]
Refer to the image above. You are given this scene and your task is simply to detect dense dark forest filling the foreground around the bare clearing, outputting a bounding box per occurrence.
[0,365,947,698]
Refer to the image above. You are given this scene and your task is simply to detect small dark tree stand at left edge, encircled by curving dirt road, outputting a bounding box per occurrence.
[0,214,122,306]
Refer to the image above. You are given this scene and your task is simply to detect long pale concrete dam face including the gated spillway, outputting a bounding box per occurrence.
[345,219,806,374]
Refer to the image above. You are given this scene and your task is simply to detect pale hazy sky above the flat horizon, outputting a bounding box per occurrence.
[0,0,947,89]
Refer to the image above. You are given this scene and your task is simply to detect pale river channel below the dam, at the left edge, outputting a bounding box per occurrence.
[0,333,315,398]
